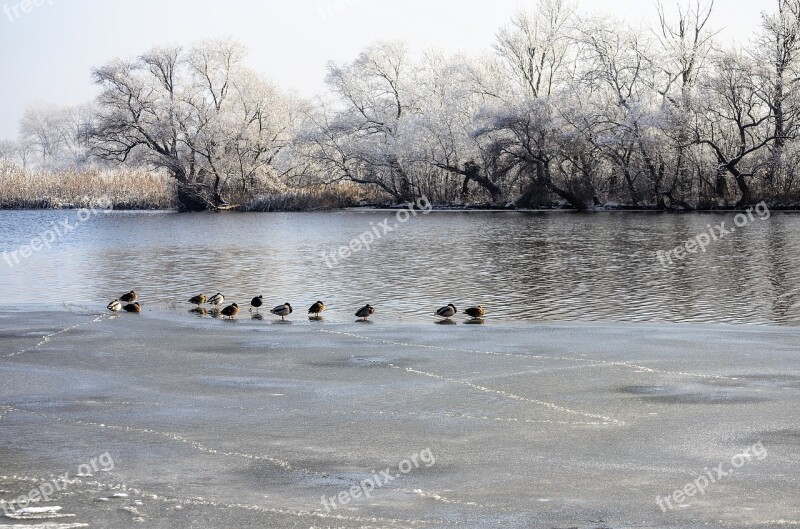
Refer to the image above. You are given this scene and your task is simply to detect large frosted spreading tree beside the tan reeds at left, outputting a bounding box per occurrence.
[92,41,296,209]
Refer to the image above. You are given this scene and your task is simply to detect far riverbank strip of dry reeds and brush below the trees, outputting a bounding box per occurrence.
[7,161,800,213]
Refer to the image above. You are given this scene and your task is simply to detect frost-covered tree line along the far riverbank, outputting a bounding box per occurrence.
[0,0,800,210]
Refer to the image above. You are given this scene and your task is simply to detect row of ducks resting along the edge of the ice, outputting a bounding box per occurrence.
[108,290,486,321]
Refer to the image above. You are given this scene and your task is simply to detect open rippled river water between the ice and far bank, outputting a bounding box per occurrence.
[0,211,800,325]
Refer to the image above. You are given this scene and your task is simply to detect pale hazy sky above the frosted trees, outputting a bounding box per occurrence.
[0,0,774,139]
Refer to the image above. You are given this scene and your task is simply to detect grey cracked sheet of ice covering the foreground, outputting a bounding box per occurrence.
[0,307,800,528]
